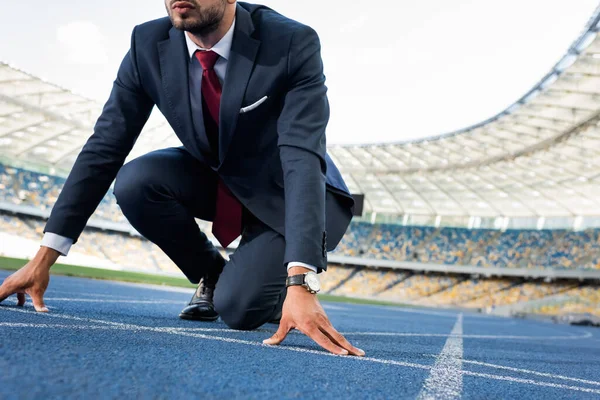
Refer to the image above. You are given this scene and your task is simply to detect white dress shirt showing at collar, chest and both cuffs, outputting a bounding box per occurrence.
[42,20,317,272]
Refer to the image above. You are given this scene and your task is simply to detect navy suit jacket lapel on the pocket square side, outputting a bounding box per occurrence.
[219,5,260,164]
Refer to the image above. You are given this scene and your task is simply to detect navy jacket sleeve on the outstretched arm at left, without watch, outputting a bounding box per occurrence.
[44,29,154,242]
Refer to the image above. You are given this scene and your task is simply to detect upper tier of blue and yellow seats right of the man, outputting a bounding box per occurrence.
[336,222,600,269]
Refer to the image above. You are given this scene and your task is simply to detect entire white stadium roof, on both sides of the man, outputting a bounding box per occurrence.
[0,8,600,217]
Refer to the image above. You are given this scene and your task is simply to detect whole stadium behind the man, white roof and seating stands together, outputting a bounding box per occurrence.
[0,7,600,316]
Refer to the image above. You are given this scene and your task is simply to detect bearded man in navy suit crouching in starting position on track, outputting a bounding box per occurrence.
[0,0,364,355]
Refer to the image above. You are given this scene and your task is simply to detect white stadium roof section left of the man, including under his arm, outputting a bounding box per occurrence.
[0,63,181,170]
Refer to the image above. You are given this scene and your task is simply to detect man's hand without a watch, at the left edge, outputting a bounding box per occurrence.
[0,247,60,312]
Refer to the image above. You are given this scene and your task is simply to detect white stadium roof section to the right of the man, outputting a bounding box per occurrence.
[329,8,600,217]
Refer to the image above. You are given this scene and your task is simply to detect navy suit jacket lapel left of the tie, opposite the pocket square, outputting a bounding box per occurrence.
[158,28,210,156]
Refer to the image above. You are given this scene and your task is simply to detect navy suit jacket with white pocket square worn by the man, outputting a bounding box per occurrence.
[45,3,353,269]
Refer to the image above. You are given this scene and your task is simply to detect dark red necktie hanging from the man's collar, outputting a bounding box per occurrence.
[196,51,242,248]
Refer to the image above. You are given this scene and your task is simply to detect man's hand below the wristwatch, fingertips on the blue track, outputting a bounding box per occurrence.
[263,270,365,356]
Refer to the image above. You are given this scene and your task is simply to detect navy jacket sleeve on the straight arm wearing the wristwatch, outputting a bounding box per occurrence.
[278,27,329,269]
